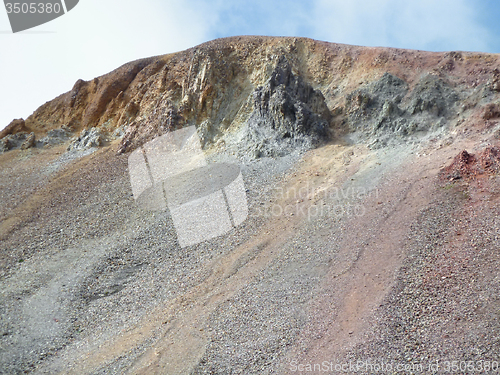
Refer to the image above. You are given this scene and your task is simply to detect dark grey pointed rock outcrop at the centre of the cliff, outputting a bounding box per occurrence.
[240,58,330,157]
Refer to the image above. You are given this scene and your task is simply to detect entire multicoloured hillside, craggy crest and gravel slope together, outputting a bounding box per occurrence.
[0,37,500,374]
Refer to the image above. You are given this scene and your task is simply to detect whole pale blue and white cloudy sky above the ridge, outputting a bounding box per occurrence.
[0,0,500,129]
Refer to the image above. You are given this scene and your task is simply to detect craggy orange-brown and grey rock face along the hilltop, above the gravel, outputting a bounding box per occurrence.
[0,37,500,156]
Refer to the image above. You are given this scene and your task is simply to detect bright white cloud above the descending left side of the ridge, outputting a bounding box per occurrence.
[0,0,216,129]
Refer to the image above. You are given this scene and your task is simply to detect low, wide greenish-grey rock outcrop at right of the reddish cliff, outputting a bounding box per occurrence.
[346,73,459,146]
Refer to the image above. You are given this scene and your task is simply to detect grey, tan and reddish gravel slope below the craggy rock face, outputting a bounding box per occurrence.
[0,130,500,374]
